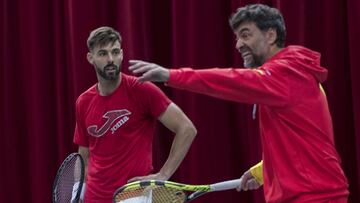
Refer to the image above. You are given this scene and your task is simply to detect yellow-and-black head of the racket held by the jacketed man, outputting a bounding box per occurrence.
[113,180,209,203]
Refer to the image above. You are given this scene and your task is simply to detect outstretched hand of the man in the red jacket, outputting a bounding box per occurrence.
[129,60,170,82]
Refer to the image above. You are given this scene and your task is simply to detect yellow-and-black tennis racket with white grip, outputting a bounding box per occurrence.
[113,179,241,203]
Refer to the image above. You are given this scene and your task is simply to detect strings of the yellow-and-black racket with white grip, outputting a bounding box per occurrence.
[115,186,186,203]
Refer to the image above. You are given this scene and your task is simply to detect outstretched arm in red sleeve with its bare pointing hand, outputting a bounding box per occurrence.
[129,60,290,107]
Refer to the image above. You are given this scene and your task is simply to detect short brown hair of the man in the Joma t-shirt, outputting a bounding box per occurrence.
[87,27,121,51]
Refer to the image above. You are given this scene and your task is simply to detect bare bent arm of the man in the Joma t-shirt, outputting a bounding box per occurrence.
[128,103,196,182]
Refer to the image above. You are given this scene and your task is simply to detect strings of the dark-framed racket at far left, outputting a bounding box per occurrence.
[55,156,81,203]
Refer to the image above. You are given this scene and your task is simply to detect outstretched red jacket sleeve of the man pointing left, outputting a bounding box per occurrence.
[167,68,289,106]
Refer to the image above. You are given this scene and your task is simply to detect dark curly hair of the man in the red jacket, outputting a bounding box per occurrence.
[229,4,286,47]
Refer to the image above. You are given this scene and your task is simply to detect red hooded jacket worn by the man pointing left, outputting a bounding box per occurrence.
[167,46,349,203]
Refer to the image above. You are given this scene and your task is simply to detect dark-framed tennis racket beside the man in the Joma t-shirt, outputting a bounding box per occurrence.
[52,153,85,203]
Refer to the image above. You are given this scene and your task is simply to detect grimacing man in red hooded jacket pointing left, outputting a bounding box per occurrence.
[129,4,349,203]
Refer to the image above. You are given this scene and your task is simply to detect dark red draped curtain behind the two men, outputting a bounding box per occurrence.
[0,0,360,203]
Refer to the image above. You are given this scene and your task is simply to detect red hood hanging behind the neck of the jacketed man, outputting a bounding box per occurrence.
[273,46,328,83]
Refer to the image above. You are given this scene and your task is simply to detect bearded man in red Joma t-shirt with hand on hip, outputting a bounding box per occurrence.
[74,27,196,203]
